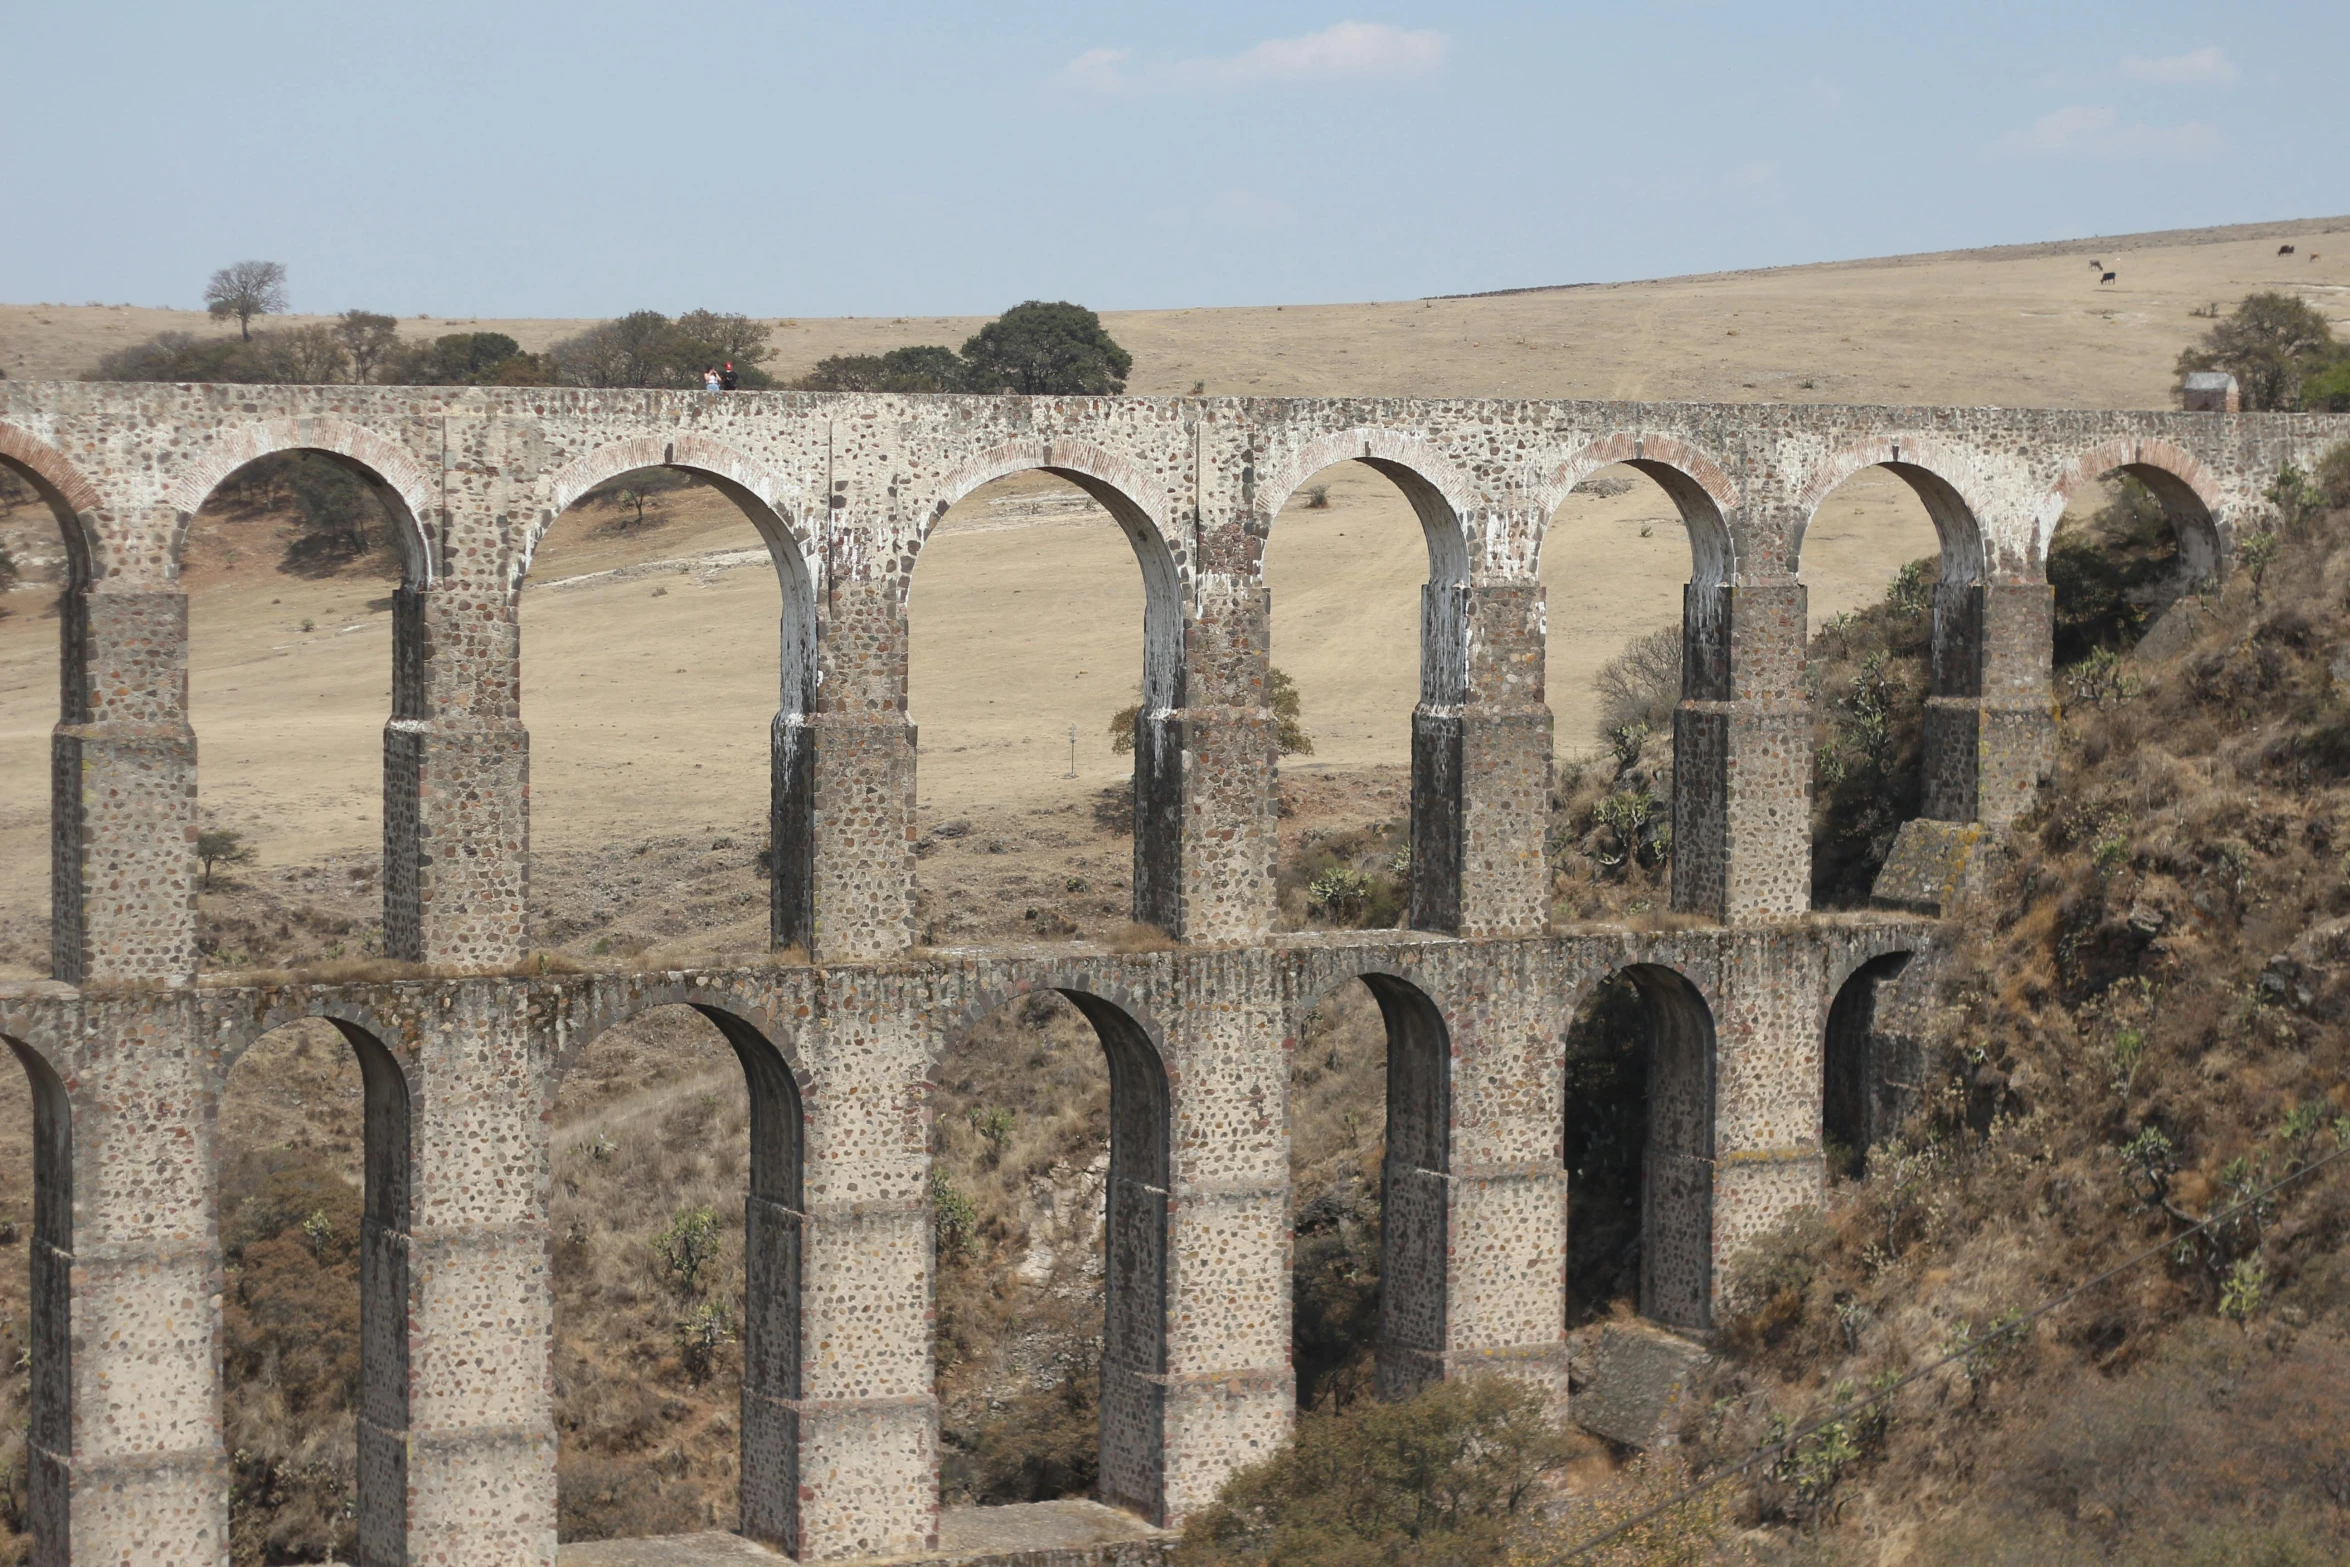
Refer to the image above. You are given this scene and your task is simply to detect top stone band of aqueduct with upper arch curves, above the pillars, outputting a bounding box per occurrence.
[0,383,2350,596]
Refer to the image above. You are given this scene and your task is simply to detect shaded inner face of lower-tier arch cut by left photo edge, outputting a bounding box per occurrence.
[0,1034,75,1562]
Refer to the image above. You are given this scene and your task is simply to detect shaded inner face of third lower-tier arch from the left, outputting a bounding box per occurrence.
[548,1000,811,1555]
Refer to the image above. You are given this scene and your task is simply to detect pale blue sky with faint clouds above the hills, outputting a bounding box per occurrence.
[0,0,2350,315]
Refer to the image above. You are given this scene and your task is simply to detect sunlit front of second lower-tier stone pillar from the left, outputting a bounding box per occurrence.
[399,982,555,1567]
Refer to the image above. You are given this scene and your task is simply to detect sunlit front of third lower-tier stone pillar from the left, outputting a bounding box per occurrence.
[789,968,938,1562]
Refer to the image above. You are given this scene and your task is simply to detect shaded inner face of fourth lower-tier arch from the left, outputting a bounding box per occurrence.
[928,970,1175,1522]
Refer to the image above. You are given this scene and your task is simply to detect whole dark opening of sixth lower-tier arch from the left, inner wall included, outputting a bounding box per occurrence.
[1563,963,1716,1332]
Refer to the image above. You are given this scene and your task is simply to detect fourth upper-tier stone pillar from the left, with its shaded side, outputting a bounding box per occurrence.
[1135,573,1281,942]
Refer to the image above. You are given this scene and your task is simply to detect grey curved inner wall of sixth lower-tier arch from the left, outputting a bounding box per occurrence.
[1565,961,1716,1332]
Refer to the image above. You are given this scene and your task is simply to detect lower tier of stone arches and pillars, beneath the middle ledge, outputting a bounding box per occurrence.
[0,916,1936,1562]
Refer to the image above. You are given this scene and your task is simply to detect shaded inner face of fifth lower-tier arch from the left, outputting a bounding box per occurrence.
[1290,968,1452,1398]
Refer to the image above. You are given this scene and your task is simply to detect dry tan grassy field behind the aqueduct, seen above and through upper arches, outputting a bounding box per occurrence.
[0,221,2350,975]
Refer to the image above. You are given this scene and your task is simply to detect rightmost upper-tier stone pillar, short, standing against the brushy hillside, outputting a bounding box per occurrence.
[1925,583,2056,827]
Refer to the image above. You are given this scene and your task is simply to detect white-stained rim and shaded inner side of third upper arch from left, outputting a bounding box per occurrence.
[524,432,823,947]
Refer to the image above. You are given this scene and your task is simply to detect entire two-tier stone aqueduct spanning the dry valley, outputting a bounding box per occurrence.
[0,383,2350,1565]
